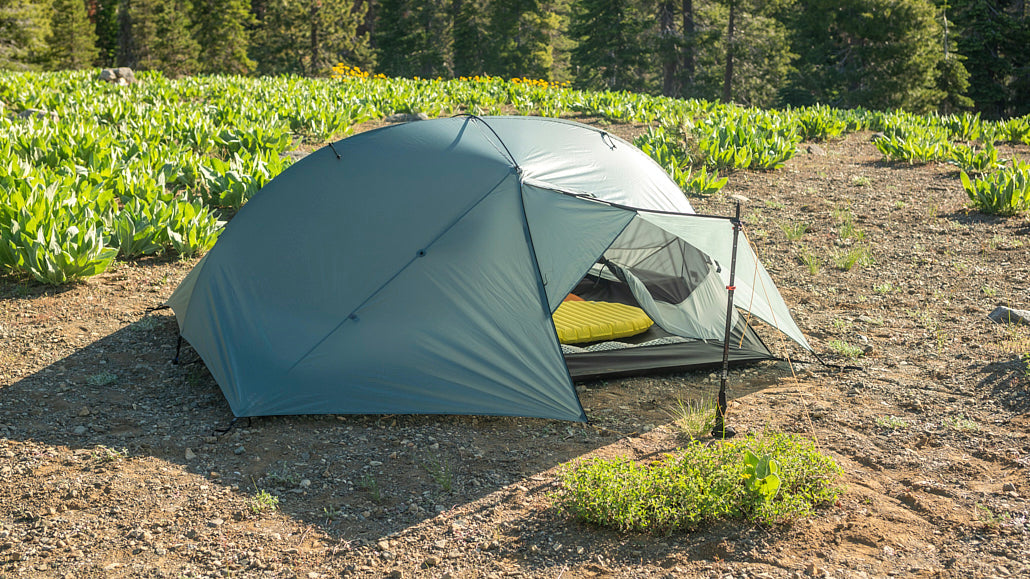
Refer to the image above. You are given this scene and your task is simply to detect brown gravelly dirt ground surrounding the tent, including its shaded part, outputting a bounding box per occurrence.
[6,118,1030,579]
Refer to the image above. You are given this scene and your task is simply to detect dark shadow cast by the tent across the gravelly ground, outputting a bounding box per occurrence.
[0,312,782,545]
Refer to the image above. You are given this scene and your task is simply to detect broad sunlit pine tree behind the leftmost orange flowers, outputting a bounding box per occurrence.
[251,0,375,76]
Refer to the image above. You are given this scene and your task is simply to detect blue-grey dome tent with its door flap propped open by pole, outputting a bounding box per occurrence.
[167,116,811,420]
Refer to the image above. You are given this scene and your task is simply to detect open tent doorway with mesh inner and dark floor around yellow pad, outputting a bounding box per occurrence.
[547,206,776,380]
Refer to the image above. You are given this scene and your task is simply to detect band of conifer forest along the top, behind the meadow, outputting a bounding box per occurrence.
[0,0,1030,118]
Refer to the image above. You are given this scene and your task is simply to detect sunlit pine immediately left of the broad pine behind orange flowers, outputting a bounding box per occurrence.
[194,0,255,74]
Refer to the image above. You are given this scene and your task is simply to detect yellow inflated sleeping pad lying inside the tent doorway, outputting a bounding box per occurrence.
[552,302,654,344]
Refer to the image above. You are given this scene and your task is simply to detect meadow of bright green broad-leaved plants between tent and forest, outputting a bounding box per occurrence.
[0,69,1030,284]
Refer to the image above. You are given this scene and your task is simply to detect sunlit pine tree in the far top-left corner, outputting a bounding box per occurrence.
[0,0,49,70]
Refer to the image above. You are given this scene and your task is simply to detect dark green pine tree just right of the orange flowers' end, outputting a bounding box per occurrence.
[569,0,647,91]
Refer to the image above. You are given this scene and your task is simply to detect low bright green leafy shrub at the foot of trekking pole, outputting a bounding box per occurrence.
[552,432,842,533]
